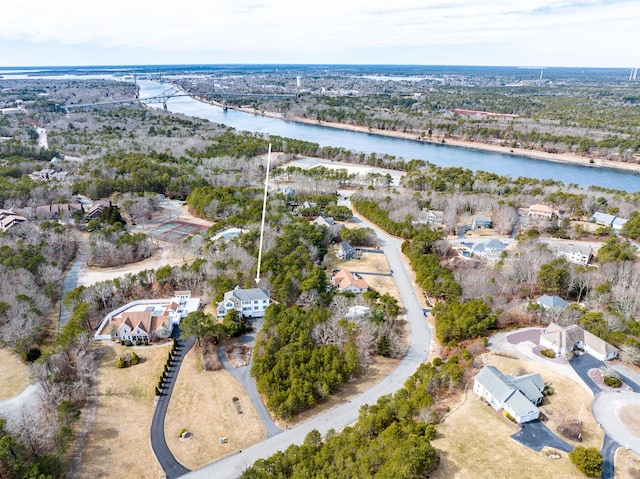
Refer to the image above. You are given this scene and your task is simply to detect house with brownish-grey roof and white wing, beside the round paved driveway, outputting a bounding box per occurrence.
[540,323,618,361]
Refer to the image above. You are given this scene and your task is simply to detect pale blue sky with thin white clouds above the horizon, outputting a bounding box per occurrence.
[0,0,640,67]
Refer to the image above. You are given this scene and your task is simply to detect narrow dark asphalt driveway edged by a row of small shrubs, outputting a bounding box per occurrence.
[150,338,195,479]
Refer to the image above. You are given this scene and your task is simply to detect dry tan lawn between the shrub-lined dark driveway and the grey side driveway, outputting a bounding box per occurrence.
[165,348,267,469]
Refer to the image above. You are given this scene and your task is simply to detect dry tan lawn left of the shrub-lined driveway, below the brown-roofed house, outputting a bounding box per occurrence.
[75,343,171,479]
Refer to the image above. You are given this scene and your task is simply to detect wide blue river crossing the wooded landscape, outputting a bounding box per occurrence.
[138,80,640,192]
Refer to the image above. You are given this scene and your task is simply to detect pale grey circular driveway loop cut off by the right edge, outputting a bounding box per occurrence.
[591,391,640,454]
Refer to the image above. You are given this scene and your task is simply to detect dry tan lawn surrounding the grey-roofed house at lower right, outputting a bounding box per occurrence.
[431,354,603,479]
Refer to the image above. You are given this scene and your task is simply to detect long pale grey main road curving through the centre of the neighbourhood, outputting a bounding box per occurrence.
[185,204,431,479]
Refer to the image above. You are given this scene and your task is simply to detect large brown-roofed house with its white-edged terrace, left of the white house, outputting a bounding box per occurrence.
[94,291,200,342]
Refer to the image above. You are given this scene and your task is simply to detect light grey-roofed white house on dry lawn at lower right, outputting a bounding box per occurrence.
[473,366,544,424]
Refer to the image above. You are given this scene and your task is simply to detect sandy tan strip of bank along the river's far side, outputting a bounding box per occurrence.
[189,97,640,173]
